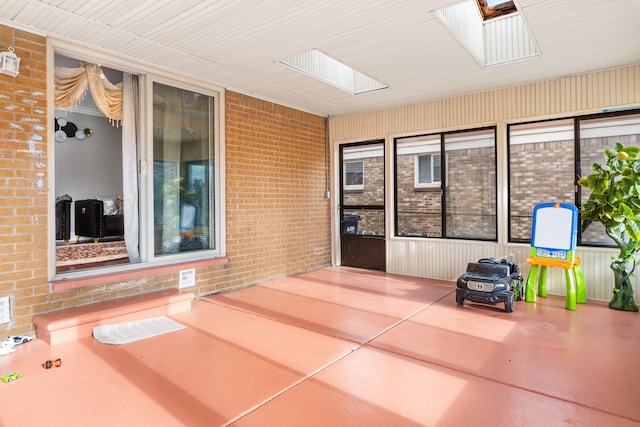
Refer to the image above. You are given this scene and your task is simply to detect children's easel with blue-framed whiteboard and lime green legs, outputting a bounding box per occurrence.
[525,203,587,310]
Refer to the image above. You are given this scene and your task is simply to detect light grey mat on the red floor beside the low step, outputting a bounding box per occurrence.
[93,316,186,345]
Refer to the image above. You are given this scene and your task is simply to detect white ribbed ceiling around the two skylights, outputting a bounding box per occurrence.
[0,0,640,116]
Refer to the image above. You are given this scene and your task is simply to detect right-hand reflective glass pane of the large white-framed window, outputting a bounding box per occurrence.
[153,82,214,256]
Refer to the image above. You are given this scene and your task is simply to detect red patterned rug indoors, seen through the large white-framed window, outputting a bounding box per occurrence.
[56,240,129,266]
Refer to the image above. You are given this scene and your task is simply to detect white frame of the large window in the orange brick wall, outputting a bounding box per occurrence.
[47,39,226,282]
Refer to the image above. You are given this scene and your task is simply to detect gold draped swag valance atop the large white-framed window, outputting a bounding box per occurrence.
[54,63,123,123]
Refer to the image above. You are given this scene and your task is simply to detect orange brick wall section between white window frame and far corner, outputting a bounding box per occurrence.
[226,92,331,286]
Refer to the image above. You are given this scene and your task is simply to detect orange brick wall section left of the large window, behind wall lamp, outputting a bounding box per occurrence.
[0,26,49,336]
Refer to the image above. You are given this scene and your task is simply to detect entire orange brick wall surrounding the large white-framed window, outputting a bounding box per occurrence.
[0,26,331,338]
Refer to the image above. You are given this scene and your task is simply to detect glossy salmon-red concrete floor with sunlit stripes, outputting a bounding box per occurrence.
[0,268,640,427]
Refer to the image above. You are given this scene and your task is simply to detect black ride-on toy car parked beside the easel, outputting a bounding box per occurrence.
[456,258,523,313]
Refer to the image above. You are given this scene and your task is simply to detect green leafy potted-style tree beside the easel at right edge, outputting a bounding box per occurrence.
[578,143,640,312]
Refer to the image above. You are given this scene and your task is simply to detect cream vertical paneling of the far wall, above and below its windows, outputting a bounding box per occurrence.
[330,65,640,301]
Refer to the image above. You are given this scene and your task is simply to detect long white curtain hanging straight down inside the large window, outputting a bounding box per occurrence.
[122,73,140,263]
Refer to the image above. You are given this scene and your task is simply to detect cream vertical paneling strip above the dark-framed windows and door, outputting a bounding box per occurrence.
[330,65,640,141]
